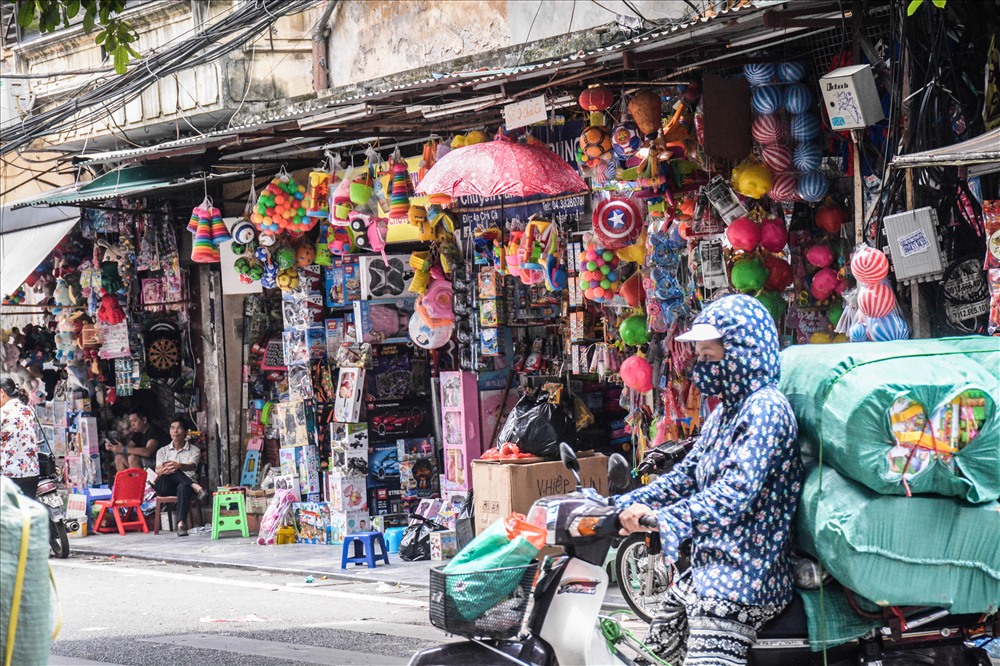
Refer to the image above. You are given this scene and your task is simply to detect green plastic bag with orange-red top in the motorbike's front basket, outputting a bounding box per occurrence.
[441,513,545,622]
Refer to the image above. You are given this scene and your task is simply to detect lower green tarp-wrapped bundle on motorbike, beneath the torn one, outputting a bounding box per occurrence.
[795,467,1000,613]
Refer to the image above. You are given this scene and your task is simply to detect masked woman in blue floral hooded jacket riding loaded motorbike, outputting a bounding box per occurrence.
[616,295,802,666]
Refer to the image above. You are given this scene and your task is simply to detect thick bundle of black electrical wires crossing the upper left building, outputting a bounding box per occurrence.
[0,0,315,155]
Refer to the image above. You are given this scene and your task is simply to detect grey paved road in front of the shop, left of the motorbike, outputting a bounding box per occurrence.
[50,558,444,666]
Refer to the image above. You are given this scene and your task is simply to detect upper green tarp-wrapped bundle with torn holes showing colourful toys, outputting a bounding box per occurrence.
[781,336,1000,503]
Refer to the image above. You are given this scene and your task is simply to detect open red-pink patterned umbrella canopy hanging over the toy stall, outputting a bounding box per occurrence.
[416,141,587,199]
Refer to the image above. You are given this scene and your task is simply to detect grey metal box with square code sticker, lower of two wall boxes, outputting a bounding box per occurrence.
[883,207,944,283]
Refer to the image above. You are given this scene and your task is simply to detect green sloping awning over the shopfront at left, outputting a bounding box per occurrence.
[41,166,252,207]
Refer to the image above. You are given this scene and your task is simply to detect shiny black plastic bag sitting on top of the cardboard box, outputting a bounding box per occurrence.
[497,391,576,460]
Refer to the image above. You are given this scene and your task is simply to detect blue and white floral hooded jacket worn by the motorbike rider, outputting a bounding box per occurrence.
[616,295,802,606]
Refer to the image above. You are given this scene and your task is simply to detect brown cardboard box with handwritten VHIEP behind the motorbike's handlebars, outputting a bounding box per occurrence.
[472,455,608,534]
